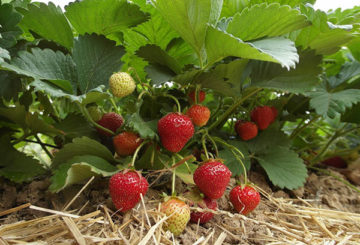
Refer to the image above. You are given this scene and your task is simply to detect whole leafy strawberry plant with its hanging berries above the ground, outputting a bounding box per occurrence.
[0,0,360,218]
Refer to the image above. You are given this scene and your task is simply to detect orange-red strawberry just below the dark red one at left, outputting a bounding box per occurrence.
[113,132,143,156]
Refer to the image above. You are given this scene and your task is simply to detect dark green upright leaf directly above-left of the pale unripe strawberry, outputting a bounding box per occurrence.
[73,34,124,93]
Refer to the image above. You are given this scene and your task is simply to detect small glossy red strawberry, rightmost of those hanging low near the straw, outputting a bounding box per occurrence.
[230,185,260,215]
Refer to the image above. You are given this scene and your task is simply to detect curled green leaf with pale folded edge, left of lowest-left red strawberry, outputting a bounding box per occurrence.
[49,155,118,192]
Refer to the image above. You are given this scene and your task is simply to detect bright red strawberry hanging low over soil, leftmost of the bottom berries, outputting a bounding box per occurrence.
[109,170,149,212]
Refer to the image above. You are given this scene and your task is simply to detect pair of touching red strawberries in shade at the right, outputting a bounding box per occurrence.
[235,106,278,141]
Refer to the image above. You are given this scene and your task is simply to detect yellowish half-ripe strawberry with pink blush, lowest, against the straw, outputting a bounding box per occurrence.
[160,197,190,236]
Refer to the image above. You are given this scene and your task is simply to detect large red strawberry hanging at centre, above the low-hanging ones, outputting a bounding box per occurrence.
[158,113,195,152]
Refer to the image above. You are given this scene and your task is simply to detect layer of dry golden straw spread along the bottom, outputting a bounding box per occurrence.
[0,171,360,245]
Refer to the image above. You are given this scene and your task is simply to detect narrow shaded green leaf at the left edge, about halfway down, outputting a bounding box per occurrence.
[0,104,62,134]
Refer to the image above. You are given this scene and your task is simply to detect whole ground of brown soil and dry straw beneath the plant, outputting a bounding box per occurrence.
[0,172,360,245]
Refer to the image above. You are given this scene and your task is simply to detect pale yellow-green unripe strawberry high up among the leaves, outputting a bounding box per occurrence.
[109,72,136,98]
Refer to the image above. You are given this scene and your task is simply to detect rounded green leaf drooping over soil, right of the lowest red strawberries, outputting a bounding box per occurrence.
[256,144,307,190]
